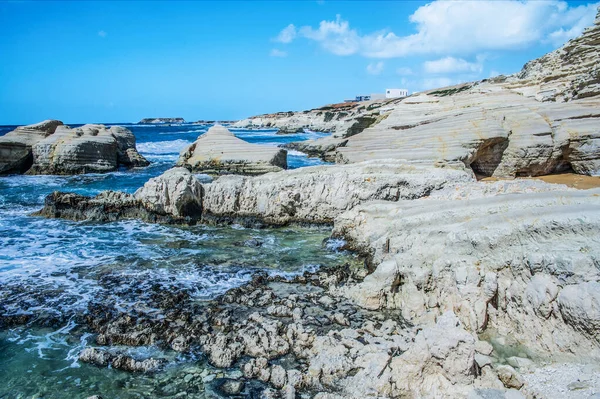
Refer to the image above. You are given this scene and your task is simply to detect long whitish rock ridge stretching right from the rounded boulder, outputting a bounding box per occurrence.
[203,160,474,225]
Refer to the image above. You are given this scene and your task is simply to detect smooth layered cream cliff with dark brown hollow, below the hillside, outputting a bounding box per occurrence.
[335,83,600,177]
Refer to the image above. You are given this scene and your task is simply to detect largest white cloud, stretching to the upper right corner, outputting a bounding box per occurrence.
[288,0,600,58]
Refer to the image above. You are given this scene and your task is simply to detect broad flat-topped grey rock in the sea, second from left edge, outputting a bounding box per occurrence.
[27,125,149,175]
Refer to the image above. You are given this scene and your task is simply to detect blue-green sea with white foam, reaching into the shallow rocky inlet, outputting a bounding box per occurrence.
[0,125,353,398]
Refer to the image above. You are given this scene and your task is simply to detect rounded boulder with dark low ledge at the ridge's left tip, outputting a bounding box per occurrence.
[33,168,202,224]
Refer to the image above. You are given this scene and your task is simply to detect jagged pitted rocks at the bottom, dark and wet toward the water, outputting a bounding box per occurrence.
[0,258,524,398]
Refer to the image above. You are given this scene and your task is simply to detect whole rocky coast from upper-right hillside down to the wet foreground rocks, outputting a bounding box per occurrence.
[0,6,600,399]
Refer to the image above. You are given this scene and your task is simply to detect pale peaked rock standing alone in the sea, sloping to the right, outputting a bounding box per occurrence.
[177,125,287,175]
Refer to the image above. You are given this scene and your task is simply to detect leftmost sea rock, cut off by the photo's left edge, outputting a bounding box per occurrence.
[0,120,63,174]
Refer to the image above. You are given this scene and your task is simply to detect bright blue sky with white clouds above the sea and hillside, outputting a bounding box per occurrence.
[0,0,598,124]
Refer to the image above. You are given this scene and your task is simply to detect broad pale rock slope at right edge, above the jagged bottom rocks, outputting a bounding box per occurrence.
[335,182,600,356]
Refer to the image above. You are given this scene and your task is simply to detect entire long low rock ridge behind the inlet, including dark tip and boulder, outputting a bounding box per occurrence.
[35,160,474,225]
